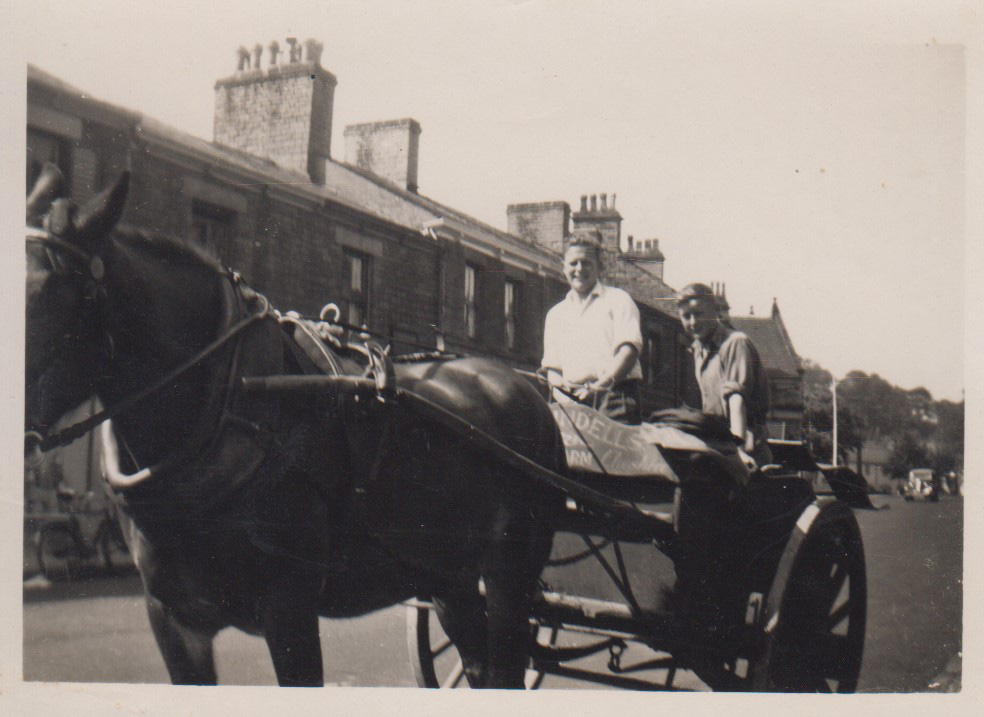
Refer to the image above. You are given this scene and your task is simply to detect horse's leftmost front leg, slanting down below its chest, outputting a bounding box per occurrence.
[147,595,216,685]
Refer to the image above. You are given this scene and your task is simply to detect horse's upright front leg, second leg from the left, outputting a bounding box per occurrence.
[260,581,325,687]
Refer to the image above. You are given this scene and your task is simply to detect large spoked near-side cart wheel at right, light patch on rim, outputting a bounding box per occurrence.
[750,501,867,692]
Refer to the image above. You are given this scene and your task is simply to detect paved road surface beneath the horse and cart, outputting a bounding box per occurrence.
[24,496,963,692]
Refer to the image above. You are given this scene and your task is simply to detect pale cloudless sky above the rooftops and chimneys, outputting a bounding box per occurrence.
[0,0,981,400]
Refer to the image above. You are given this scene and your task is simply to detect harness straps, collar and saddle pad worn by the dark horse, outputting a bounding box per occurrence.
[25,220,404,532]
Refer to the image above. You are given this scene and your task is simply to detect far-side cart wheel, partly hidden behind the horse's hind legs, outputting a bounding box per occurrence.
[407,600,557,690]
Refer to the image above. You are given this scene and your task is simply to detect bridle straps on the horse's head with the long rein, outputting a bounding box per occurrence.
[24,227,271,459]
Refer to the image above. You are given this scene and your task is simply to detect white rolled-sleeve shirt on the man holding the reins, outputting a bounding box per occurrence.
[541,281,642,383]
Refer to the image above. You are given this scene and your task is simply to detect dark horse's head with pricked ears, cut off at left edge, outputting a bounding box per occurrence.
[25,164,129,434]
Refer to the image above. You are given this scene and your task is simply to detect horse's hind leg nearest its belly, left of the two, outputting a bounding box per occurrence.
[434,579,488,687]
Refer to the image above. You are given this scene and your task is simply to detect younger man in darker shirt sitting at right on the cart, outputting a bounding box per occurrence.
[677,284,772,468]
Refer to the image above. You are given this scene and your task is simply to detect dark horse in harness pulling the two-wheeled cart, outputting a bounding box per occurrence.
[25,166,565,688]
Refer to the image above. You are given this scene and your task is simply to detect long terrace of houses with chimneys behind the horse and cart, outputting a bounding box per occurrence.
[27,40,696,504]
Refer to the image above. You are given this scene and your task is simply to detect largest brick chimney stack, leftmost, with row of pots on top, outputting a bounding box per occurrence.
[213,37,337,184]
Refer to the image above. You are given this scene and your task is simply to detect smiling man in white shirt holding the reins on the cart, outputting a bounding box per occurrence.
[541,237,642,425]
